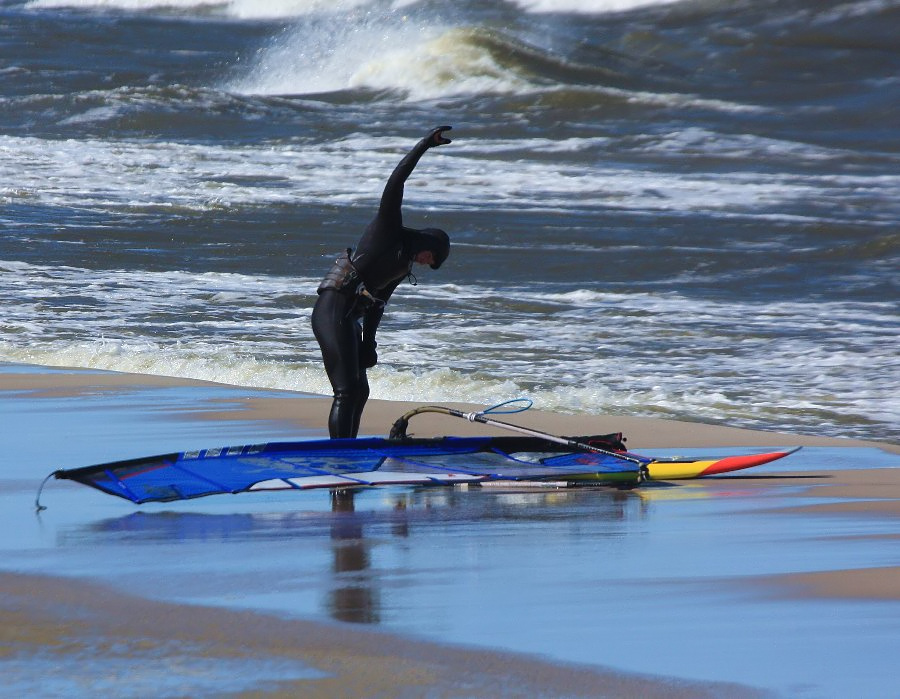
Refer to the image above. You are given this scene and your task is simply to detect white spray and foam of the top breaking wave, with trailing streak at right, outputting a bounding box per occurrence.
[223,17,768,106]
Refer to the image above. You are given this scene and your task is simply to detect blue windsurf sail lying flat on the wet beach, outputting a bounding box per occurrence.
[47,436,650,508]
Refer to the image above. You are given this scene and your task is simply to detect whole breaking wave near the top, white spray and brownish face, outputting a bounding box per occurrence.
[218,13,770,108]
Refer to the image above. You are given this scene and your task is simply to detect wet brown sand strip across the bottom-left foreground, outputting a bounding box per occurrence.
[0,574,761,699]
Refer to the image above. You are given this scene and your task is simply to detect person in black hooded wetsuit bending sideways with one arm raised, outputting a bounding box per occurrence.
[312,126,451,439]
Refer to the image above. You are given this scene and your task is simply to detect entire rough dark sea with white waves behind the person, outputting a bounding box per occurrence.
[0,0,900,442]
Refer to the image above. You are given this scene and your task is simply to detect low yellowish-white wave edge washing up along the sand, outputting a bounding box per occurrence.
[0,340,900,439]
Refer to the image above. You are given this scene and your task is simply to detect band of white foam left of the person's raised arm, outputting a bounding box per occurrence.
[0,136,428,210]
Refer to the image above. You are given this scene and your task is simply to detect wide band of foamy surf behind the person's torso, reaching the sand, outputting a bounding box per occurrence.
[0,262,900,440]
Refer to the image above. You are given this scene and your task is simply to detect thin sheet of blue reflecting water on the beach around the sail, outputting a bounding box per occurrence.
[0,378,900,697]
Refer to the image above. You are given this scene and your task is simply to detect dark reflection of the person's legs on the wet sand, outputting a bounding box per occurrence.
[328,490,381,624]
